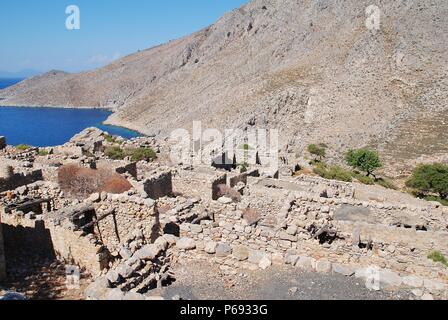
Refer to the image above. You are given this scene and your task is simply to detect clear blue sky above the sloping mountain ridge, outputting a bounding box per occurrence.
[0,0,247,72]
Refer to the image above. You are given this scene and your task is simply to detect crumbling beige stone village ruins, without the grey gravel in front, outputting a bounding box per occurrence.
[0,129,448,300]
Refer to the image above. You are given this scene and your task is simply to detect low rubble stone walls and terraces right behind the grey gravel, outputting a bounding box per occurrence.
[181,189,448,292]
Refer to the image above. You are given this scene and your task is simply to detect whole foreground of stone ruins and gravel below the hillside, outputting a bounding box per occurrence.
[0,128,448,300]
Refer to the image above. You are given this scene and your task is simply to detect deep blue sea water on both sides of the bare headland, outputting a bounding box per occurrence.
[0,79,140,147]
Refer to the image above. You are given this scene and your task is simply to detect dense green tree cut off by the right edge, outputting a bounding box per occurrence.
[406,163,448,199]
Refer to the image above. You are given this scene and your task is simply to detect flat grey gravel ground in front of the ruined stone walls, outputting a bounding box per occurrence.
[161,261,412,300]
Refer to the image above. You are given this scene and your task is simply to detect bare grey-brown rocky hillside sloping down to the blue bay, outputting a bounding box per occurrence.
[0,0,448,169]
